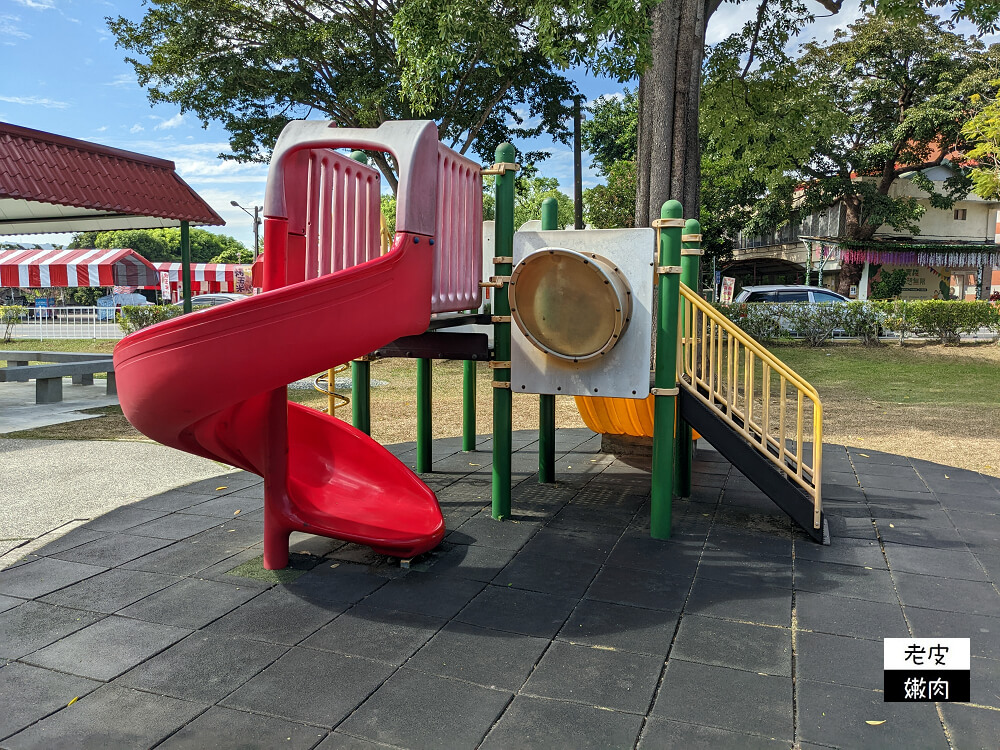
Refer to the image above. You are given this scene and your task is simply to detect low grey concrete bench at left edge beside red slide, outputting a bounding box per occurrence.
[0,351,118,404]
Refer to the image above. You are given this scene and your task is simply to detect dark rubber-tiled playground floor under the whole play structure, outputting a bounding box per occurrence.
[0,430,1000,750]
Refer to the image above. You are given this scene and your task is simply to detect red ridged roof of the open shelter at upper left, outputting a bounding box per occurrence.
[0,122,225,232]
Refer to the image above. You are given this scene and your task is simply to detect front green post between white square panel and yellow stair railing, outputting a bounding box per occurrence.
[649,200,684,539]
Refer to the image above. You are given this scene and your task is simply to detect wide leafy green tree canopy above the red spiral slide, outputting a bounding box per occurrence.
[108,0,575,190]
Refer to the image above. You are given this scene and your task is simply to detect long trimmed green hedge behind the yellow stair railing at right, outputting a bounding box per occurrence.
[716,300,1000,346]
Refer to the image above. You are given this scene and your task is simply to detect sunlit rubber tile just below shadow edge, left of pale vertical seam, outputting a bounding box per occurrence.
[670,614,792,677]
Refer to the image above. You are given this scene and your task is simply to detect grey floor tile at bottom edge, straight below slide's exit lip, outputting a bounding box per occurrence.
[339,668,512,750]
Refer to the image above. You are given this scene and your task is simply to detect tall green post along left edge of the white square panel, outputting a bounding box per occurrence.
[493,143,517,518]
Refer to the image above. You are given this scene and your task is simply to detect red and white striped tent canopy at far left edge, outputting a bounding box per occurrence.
[0,250,159,287]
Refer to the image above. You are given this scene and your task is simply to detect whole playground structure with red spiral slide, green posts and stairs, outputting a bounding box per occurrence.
[114,121,823,569]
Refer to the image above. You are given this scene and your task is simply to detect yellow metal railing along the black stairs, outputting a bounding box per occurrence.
[677,284,823,529]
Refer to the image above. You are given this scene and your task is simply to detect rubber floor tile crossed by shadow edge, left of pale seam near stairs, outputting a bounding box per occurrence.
[685,576,792,628]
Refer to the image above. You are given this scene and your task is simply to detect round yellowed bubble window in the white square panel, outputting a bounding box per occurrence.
[509,247,632,362]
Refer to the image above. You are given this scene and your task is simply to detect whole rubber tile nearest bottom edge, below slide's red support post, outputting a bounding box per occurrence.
[222,648,396,729]
